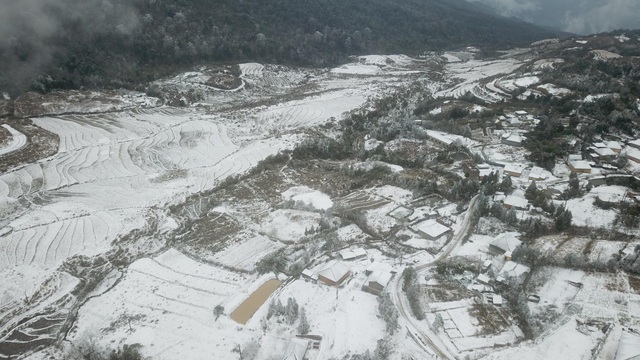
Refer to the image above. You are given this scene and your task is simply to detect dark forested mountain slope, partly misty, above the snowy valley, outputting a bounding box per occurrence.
[0,0,558,94]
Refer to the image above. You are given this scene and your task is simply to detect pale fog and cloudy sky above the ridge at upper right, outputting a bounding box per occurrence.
[468,0,640,34]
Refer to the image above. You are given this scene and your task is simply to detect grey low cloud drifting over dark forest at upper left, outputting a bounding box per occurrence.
[0,0,138,90]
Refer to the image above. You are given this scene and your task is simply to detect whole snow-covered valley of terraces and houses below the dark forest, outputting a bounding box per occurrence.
[0,34,640,360]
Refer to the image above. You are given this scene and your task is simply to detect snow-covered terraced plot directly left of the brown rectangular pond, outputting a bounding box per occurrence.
[71,250,255,359]
